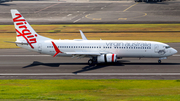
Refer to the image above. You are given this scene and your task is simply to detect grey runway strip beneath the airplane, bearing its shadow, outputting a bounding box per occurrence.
[0,43,180,79]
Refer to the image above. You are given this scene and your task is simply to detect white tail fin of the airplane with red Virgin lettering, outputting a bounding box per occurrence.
[11,9,51,49]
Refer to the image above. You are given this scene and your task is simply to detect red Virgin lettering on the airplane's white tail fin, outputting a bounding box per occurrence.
[13,13,37,49]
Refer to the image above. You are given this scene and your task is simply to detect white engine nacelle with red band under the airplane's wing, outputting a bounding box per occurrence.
[97,54,117,63]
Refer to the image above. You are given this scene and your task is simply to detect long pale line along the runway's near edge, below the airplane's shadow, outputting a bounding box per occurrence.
[0,73,180,76]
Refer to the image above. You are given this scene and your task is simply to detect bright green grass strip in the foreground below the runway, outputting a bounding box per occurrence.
[0,79,180,101]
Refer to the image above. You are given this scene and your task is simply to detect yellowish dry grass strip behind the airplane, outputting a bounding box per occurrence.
[0,24,180,48]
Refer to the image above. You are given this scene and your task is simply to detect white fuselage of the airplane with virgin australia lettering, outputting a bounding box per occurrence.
[18,39,177,58]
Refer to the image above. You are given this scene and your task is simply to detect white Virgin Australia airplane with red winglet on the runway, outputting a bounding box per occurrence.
[11,9,177,65]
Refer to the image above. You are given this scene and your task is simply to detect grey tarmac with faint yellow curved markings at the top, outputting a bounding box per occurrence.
[0,1,180,24]
